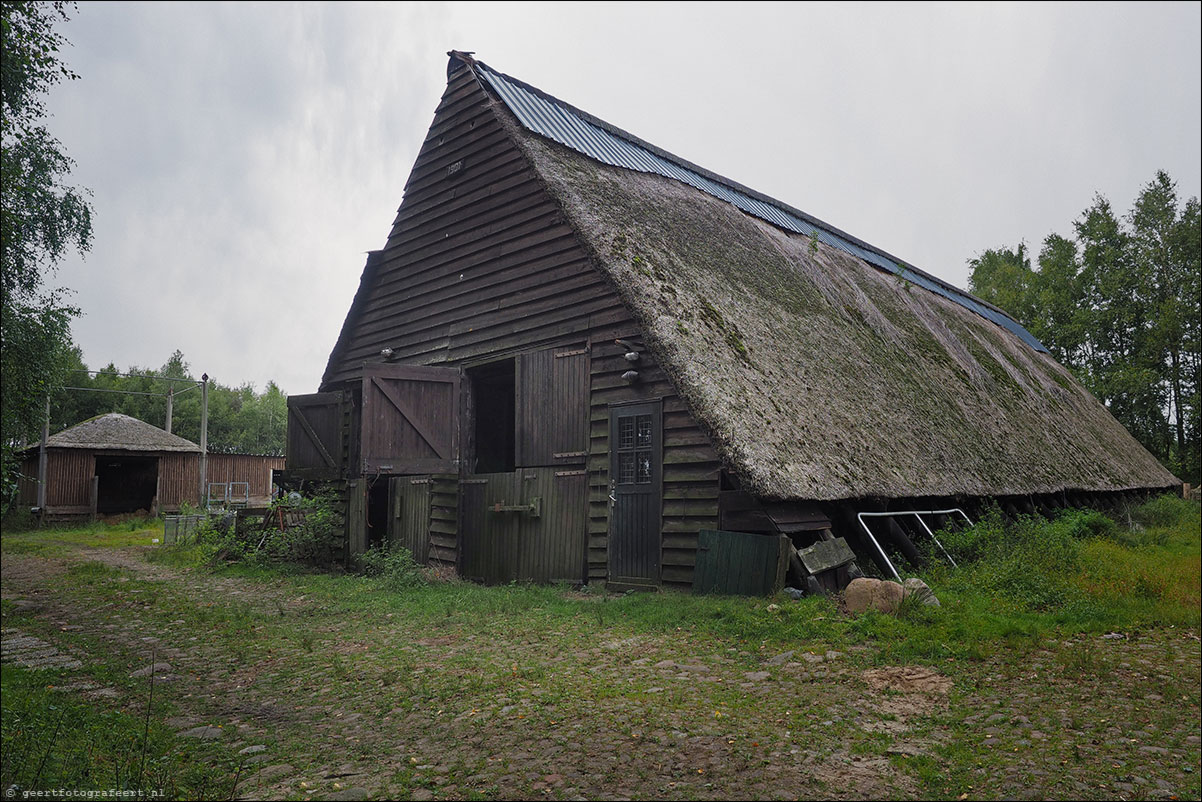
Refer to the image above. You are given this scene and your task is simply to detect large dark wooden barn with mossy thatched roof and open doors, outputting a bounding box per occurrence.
[287,52,1179,588]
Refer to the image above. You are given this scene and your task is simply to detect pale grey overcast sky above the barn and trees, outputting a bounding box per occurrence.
[42,1,1202,393]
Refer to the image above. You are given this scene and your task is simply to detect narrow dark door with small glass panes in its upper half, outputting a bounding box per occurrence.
[609,402,664,584]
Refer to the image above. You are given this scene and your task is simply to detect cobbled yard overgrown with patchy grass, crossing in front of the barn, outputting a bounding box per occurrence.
[2,538,1200,800]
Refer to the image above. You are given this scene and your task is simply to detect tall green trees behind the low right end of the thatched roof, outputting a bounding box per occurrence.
[969,172,1202,485]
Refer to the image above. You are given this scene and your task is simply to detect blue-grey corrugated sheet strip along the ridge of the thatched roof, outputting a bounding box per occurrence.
[475,61,1047,352]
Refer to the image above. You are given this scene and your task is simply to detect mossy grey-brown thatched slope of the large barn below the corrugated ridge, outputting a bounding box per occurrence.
[473,64,1178,500]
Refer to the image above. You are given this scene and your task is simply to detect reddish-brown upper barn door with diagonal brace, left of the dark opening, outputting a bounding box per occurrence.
[359,364,459,474]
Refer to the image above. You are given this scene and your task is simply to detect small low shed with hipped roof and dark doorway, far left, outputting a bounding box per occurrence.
[18,412,284,521]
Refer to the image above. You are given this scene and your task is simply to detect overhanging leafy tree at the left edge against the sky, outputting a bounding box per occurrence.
[0,2,91,510]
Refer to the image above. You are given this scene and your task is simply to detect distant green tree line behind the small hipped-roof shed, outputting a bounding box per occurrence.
[50,349,288,457]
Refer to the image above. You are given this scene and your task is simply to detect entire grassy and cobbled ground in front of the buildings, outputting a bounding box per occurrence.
[2,499,1202,798]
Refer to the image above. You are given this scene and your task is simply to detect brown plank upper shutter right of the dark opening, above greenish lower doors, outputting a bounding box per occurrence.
[517,347,589,468]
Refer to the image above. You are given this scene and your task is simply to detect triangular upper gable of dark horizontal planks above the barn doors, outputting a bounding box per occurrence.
[323,70,625,388]
